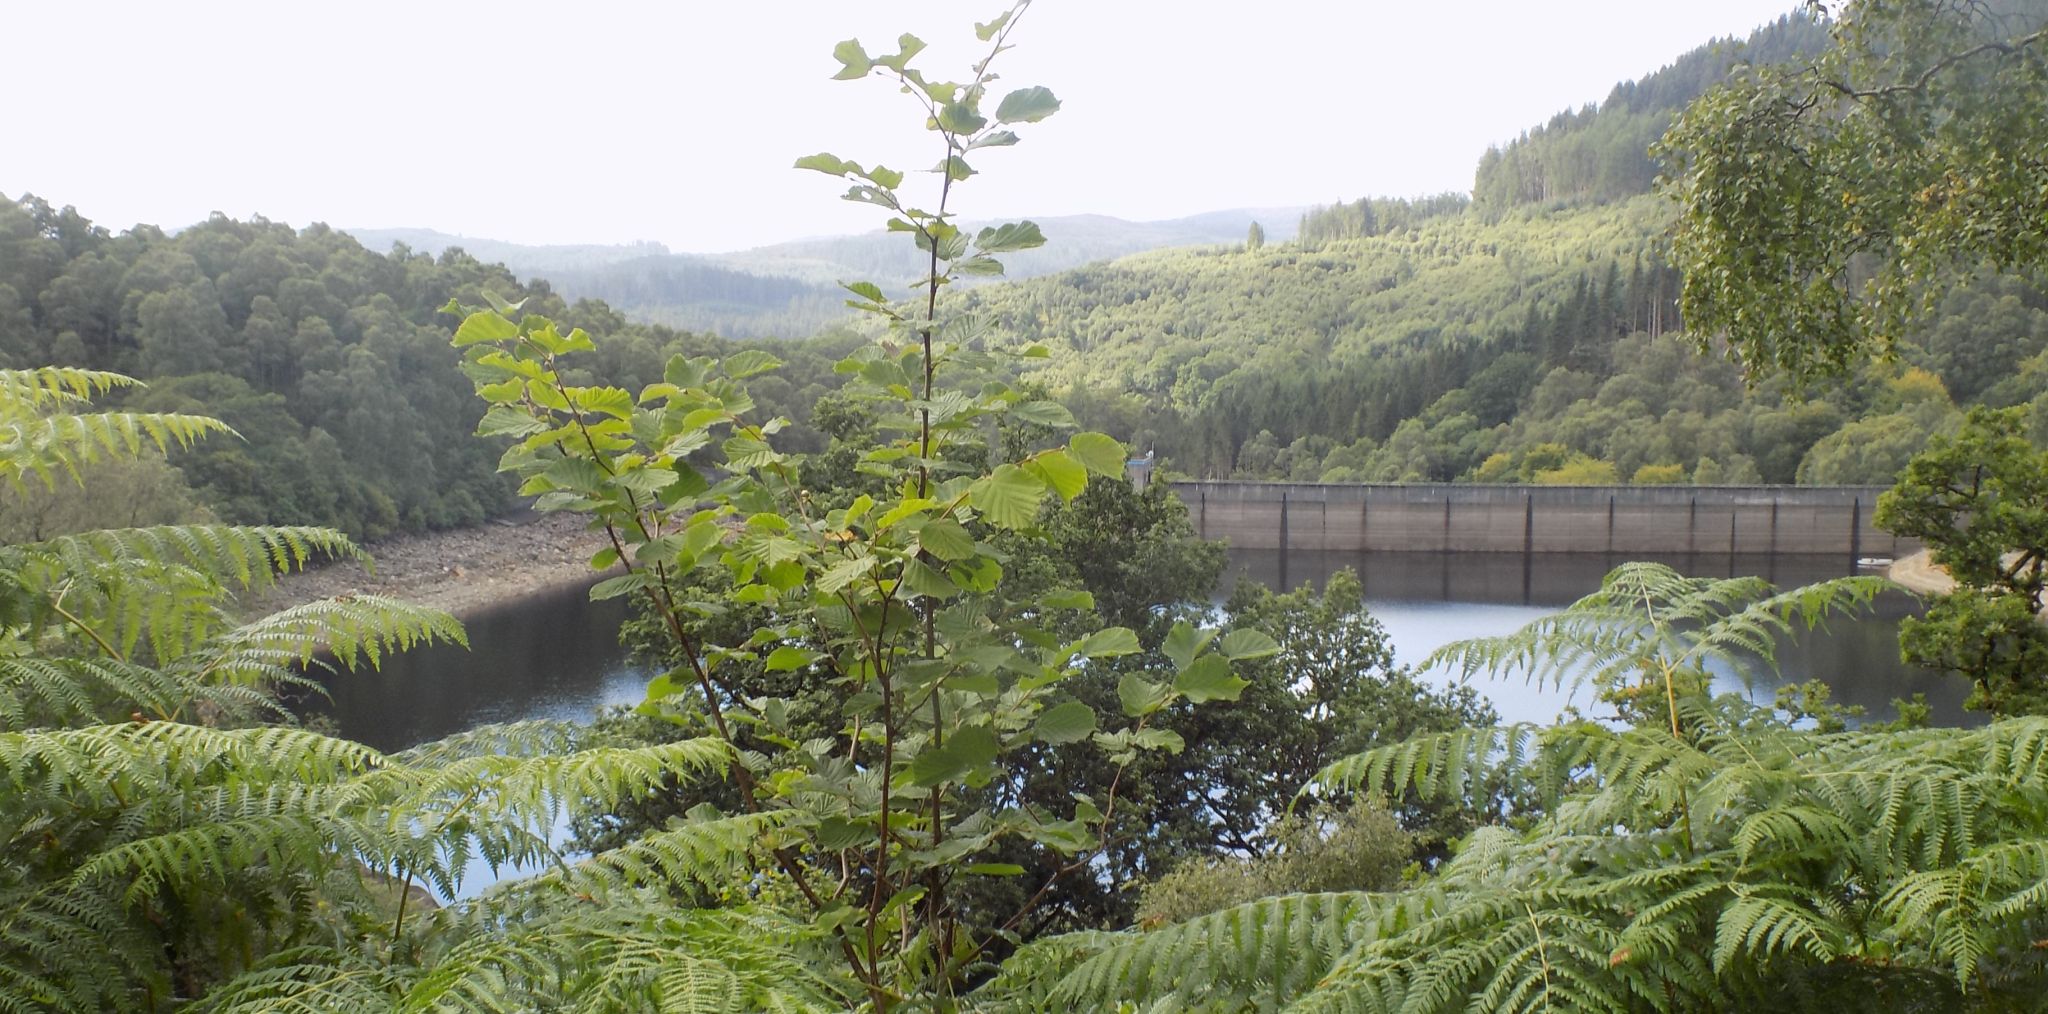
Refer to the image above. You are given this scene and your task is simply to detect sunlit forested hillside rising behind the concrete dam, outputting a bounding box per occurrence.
[961,8,2048,483]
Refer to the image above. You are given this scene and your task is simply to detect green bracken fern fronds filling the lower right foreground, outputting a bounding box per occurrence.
[981,565,2048,1010]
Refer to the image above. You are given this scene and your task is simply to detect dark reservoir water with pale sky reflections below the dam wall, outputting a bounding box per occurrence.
[311,549,1972,750]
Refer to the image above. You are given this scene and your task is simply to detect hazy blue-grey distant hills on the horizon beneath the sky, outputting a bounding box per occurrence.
[342,207,1303,338]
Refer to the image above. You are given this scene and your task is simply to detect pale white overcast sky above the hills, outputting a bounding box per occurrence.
[12,0,1794,252]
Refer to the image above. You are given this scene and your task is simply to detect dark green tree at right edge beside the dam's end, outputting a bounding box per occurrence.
[1876,408,2048,715]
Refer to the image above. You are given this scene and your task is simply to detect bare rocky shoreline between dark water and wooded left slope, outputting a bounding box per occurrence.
[250,514,606,617]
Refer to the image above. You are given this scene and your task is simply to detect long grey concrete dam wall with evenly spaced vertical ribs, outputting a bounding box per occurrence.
[1171,481,1919,559]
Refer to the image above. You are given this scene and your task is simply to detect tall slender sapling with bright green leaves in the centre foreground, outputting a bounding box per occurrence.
[449,4,1278,1012]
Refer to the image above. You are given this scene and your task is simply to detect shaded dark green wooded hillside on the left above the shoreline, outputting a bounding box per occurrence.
[0,197,856,537]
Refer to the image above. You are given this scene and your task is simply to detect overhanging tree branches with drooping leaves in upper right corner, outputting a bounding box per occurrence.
[1659,0,2048,379]
